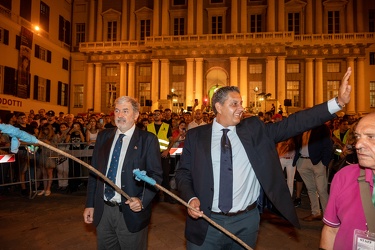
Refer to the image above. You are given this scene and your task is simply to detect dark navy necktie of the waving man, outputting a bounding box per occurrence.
[219,128,233,213]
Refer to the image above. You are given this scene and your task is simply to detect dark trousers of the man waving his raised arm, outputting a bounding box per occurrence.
[186,208,260,250]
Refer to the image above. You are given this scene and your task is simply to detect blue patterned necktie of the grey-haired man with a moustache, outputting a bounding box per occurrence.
[104,134,125,201]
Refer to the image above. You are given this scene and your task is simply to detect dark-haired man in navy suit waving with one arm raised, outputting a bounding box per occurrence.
[176,68,351,249]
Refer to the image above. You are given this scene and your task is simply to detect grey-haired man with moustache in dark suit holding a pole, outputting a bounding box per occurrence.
[83,96,162,249]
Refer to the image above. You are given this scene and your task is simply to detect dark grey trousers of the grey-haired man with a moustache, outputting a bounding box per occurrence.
[96,204,148,250]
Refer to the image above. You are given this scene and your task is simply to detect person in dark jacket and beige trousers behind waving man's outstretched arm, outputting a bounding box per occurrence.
[293,124,333,221]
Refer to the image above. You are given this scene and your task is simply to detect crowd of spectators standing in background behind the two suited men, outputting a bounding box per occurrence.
[0,95,359,203]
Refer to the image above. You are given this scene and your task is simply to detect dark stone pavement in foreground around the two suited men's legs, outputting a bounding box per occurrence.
[0,191,323,250]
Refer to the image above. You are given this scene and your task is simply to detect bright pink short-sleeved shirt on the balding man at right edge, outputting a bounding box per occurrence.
[323,164,374,250]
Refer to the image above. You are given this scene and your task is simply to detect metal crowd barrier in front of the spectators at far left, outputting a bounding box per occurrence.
[0,143,93,198]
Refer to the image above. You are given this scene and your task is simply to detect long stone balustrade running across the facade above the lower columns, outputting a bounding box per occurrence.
[79,32,375,53]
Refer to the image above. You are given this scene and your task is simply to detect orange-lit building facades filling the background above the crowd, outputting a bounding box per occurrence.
[0,0,375,114]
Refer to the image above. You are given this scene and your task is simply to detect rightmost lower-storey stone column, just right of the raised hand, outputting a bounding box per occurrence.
[358,57,370,114]
